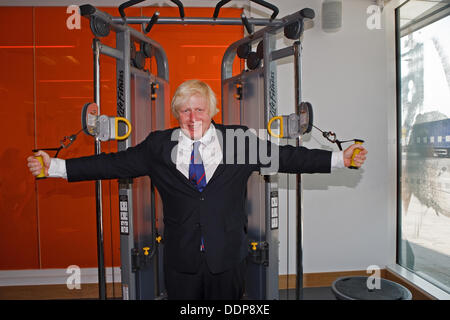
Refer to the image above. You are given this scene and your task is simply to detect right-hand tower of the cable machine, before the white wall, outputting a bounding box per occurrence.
[222,9,315,299]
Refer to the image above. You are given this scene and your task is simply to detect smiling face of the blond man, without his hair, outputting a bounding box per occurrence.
[178,94,211,140]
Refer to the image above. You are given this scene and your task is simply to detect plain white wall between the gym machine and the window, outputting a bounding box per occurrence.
[252,0,396,274]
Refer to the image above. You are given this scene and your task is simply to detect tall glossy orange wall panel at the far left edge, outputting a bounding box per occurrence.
[0,7,39,269]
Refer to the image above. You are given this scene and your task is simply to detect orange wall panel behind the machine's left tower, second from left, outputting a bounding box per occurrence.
[35,7,134,268]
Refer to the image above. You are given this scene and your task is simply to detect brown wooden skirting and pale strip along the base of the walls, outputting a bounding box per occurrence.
[0,267,433,300]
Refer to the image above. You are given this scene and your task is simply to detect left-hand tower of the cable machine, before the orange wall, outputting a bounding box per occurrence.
[80,5,169,299]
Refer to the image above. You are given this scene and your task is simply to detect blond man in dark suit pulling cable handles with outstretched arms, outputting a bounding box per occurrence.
[28,80,367,299]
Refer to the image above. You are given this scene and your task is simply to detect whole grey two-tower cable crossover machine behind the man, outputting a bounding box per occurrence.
[80,0,315,300]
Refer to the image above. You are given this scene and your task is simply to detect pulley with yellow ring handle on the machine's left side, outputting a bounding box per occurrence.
[81,103,131,141]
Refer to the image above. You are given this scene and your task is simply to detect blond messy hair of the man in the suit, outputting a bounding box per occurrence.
[170,79,219,119]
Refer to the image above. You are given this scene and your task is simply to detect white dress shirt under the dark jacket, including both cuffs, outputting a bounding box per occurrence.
[48,123,345,179]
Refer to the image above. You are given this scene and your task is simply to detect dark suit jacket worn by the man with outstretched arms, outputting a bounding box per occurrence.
[66,124,331,273]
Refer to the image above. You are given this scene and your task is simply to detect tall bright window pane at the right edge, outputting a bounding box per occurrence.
[397,1,450,292]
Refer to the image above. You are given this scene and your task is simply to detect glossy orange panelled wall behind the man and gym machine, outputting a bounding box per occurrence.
[0,7,243,270]
